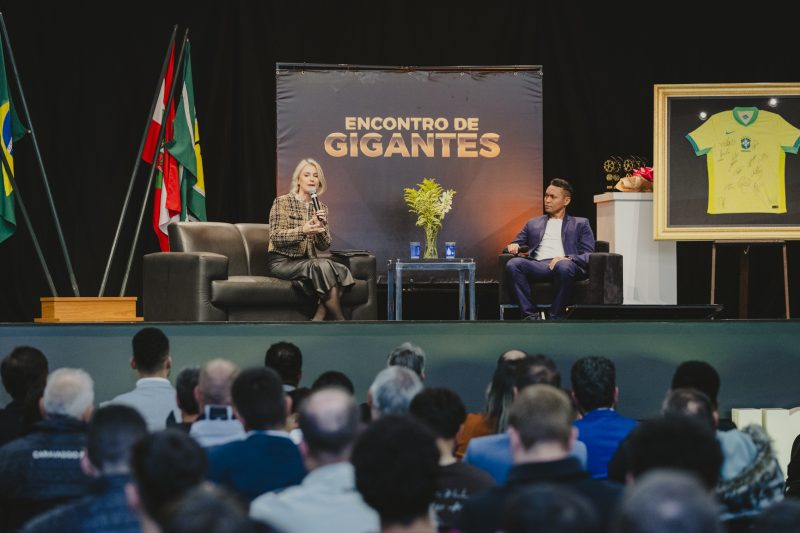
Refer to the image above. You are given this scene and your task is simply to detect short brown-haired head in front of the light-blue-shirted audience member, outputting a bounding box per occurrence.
[508,385,575,450]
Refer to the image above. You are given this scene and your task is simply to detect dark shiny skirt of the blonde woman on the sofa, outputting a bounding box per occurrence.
[267,252,356,296]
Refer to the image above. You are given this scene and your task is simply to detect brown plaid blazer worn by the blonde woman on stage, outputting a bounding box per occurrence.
[269,194,331,258]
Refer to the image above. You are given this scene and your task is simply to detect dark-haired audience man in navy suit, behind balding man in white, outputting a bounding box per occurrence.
[208,367,306,502]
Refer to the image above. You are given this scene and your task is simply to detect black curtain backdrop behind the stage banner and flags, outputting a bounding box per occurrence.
[0,0,800,321]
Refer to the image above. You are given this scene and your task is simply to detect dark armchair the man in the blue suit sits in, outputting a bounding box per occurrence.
[499,241,622,320]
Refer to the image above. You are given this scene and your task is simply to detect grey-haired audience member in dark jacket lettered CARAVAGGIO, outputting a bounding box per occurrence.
[0,368,94,530]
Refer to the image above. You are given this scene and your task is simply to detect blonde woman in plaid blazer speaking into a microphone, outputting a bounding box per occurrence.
[267,159,355,321]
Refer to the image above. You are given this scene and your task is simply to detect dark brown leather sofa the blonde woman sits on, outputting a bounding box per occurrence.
[143,222,378,322]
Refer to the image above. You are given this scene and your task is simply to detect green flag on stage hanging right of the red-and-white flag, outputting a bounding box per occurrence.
[167,42,208,221]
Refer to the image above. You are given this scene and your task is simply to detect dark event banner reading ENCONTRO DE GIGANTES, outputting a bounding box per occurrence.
[276,64,542,280]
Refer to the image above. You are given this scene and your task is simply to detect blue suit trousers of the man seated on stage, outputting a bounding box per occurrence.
[506,257,586,318]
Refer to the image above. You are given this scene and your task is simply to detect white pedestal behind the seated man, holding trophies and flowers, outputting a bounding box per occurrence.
[594,192,678,305]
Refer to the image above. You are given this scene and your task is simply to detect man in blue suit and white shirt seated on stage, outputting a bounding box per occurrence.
[506,178,594,320]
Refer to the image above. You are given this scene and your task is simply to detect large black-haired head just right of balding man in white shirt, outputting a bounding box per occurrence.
[352,416,439,526]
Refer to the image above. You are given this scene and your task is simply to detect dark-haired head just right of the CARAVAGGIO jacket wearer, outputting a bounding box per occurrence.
[86,405,147,475]
